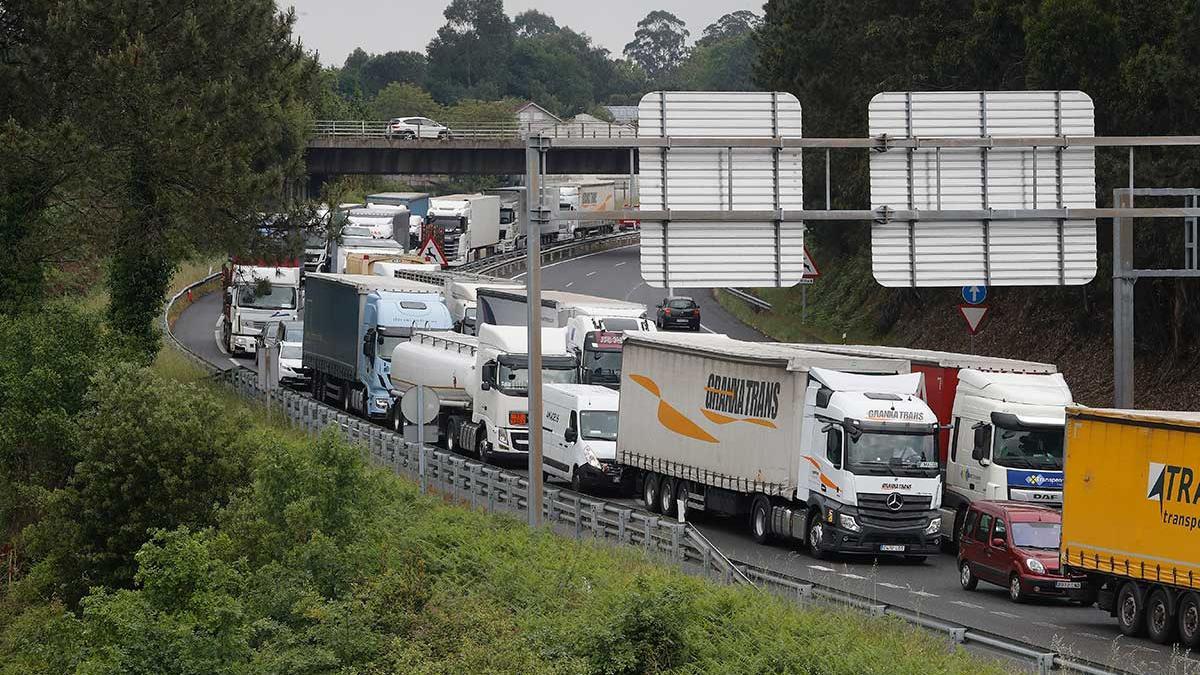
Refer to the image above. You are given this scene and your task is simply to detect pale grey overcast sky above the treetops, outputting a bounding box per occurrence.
[280,0,762,66]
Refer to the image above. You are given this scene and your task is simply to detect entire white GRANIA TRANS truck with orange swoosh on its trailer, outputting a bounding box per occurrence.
[617,333,942,558]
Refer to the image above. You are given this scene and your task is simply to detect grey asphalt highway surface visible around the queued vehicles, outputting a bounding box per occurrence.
[175,246,1200,673]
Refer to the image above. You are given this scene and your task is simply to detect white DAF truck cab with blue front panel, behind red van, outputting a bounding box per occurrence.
[943,369,1072,521]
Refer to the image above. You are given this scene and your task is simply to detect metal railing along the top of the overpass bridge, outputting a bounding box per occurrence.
[310,120,637,141]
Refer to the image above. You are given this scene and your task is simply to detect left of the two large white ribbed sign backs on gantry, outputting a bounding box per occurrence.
[637,91,804,288]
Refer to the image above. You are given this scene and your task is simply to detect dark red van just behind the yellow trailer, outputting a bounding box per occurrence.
[959,501,1087,604]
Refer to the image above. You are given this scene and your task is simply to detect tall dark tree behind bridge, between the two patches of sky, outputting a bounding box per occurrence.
[426,0,514,103]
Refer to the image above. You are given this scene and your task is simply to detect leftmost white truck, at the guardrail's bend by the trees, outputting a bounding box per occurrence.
[221,257,301,354]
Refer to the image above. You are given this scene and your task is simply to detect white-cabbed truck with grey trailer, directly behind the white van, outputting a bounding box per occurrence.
[478,288,655,388]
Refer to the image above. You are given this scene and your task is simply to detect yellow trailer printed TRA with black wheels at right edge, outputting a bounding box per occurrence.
[1061,408,1200,649]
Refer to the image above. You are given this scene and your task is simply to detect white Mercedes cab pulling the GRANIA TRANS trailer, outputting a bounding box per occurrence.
[801,368,942,555]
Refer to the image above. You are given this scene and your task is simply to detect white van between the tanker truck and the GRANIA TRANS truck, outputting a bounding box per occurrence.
[541,383,623,491]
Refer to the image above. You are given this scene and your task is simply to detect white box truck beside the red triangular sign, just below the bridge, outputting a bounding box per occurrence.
[426,195,500,263]
